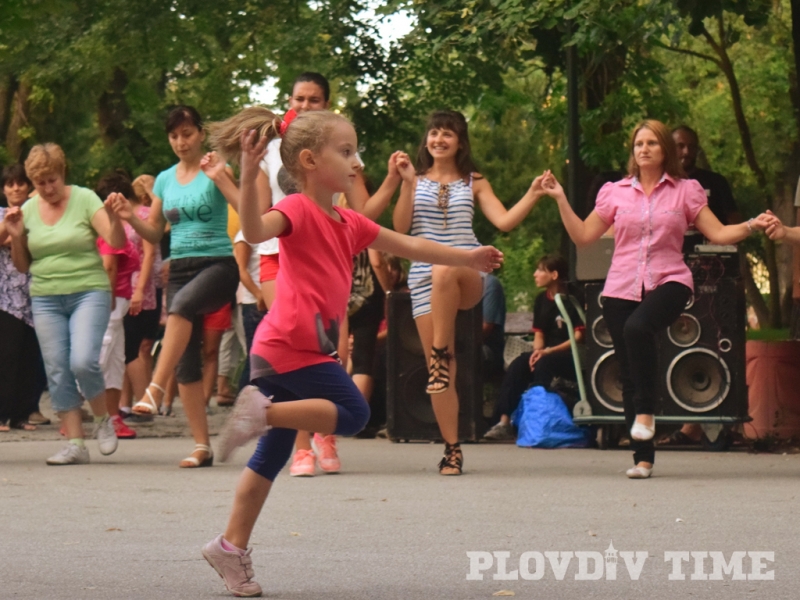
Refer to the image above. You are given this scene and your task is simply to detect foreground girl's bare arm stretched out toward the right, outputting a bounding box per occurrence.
[370,227,503,273]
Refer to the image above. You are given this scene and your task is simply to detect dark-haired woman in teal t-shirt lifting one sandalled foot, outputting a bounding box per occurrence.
[115,106,239,468]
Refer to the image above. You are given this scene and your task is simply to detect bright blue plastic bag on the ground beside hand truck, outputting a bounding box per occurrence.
[511,386,589,448]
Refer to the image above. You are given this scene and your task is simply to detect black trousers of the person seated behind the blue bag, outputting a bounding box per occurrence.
[494,350,575,423]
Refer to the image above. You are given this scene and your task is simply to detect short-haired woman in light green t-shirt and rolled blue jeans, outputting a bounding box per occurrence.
[0,144,125,465]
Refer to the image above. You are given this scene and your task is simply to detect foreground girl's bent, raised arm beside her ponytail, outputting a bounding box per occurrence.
[239,131,288,244]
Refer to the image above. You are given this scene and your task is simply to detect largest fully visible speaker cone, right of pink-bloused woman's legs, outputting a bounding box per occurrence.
[667,348,731,413]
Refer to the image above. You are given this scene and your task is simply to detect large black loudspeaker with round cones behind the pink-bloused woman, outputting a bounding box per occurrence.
[586,265,747,421]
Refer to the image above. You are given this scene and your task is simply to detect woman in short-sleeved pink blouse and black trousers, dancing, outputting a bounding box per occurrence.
[544,120,771,479]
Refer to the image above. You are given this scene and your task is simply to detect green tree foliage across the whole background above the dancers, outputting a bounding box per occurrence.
[0,0,800,322]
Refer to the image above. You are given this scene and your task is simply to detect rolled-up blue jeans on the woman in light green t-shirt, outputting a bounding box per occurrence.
[31,290,111,412]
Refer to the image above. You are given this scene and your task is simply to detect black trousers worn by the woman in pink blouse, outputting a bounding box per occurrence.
[603,281,692,463]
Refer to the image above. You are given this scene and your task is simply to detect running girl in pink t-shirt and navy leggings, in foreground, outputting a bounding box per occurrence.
[203,111,503,596]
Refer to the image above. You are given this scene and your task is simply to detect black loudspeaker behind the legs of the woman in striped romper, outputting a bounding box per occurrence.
[386,292,487,441]
